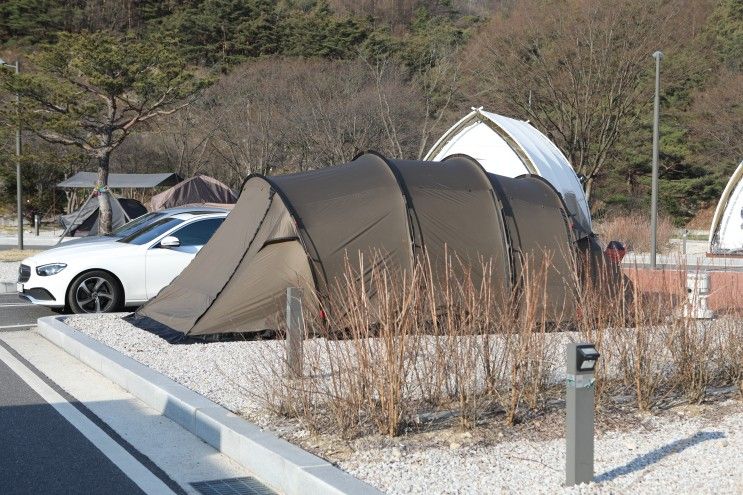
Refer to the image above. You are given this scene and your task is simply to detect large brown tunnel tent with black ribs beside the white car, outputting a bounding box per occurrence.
[131,153,575,341]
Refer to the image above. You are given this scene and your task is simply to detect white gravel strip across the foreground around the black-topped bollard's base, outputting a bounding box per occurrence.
[339,414,743,494]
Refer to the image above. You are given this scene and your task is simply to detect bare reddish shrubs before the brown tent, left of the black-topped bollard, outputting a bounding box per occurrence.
[247,250,568,437]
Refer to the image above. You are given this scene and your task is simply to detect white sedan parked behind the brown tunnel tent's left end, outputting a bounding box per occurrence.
[18,207,228,313]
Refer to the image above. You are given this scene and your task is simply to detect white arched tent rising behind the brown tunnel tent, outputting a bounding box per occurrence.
[425,107,591,235]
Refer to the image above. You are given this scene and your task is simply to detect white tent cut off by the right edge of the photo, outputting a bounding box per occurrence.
[709,162,743,254]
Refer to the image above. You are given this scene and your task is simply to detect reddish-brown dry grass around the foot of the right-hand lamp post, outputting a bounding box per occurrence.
[594,213,676,253]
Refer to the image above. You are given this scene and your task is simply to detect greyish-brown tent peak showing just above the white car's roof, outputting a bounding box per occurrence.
[147,175,237,211]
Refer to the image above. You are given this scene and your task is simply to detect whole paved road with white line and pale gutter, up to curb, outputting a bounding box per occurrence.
[0,294,264,495]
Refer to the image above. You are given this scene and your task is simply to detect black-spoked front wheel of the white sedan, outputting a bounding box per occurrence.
[67,270,124,313]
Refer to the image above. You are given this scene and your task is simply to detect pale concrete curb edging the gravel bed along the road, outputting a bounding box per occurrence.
[38,316,382,495]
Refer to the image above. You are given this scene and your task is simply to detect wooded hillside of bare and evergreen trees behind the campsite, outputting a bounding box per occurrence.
[0,0,743,224]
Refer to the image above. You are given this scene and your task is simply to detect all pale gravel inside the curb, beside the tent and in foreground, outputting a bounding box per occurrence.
[67,315,743,495]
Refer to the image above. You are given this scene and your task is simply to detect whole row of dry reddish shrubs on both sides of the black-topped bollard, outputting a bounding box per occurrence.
[251,250,743,438]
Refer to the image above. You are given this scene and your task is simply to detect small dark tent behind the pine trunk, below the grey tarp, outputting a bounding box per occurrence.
[59,194,147,237]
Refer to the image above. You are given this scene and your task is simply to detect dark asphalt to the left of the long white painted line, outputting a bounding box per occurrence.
[0,361,144,494]
